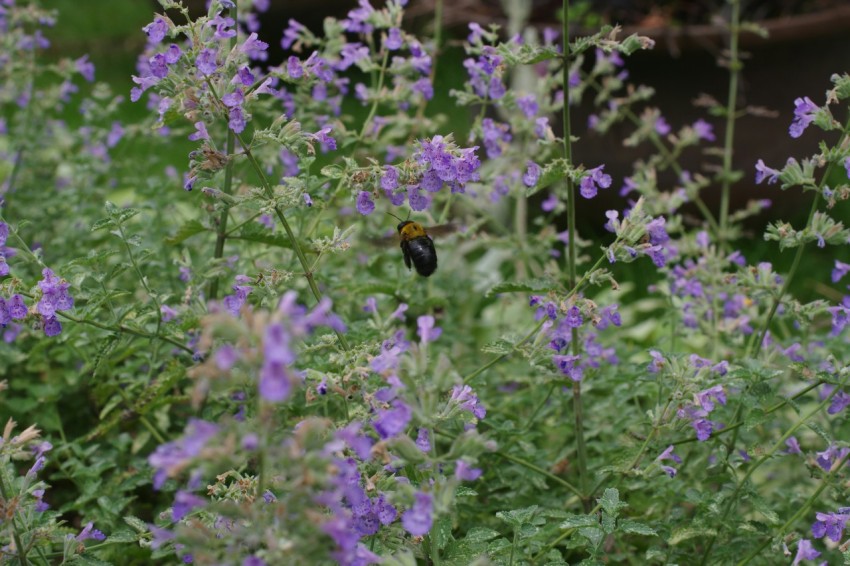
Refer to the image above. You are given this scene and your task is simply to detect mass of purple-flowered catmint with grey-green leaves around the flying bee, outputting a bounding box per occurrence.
[0,0,850,566]
